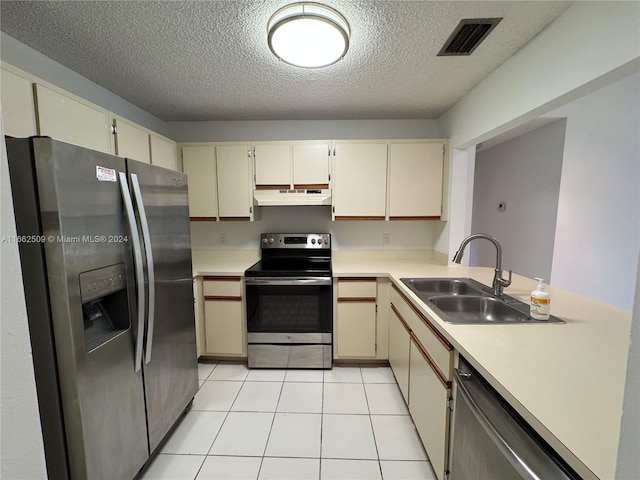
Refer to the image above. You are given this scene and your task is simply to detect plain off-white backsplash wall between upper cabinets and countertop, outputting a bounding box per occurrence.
[191,206,441,250]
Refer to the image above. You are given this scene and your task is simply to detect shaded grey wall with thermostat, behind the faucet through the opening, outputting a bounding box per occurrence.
[469,120,565,283]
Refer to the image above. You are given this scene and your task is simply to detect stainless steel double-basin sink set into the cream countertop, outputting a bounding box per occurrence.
[400,278,565,324]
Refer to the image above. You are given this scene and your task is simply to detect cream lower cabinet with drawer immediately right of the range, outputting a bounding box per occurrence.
[334,278,377,359]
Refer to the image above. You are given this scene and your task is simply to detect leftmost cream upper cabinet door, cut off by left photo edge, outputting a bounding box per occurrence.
[0,66,38,137]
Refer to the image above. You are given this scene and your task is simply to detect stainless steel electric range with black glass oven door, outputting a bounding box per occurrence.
[245,233,333,368]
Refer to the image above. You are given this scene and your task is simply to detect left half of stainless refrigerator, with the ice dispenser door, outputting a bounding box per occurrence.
[9,138,149,480]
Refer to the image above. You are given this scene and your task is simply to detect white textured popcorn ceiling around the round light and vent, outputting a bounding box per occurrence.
[0,0,571,121]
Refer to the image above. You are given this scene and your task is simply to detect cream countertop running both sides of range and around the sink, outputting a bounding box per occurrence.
[193,250,631,479]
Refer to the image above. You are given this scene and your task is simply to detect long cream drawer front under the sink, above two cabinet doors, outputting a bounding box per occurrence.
[391,285,453,380]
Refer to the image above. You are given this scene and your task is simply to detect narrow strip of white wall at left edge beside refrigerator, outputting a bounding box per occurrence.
[0,112,47,479]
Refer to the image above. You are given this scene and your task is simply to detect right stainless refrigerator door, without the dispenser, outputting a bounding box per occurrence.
[127,160,198,452]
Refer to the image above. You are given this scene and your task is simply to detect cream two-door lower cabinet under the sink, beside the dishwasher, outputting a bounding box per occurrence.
[389,285,453,480]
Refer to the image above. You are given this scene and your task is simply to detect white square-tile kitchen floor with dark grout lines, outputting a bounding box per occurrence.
[141,363,436,480]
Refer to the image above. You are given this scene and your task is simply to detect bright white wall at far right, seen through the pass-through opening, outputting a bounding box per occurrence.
[549,74,640,310]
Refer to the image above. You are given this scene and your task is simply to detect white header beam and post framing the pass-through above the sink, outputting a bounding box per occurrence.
[436,1,640,260]
